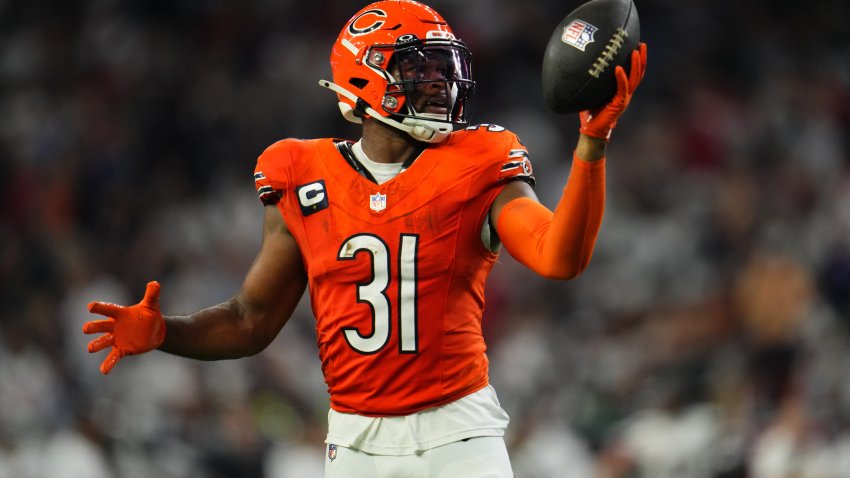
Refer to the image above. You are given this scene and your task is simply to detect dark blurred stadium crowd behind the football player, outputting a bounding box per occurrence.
[0,0,850,478]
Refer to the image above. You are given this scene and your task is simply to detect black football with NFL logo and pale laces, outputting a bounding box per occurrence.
[543,0,640,114]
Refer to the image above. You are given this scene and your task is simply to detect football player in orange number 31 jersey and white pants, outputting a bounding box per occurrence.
[83,0,646,478]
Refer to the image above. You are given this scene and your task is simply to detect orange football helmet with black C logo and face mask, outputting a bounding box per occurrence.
[319,0,475,143]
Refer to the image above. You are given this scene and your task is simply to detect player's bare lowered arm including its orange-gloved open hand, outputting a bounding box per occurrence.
[83,206,307,374]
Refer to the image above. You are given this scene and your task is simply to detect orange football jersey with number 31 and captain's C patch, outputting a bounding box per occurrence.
[254,125,533,416]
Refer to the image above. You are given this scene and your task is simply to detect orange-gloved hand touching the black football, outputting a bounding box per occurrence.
[579,43,646,141]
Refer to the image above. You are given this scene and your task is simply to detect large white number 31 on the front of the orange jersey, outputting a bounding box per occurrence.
[337,234,419,354]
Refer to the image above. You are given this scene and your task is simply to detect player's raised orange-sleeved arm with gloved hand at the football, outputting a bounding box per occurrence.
[490,44,646,279]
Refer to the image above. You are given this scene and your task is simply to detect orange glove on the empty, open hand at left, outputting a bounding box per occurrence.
[83,281,165,375]
